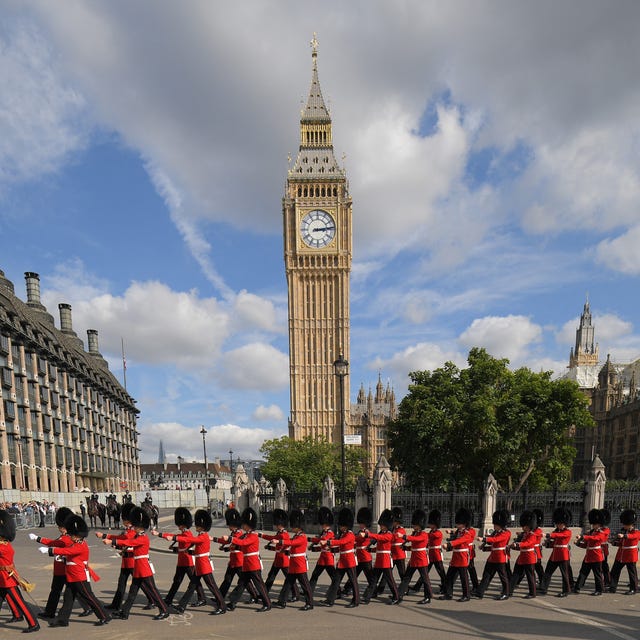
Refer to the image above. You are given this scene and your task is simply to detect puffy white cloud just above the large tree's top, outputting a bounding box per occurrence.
[458,315,542,365]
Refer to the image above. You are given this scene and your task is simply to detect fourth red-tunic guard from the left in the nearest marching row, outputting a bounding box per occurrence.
[163,509,227,616]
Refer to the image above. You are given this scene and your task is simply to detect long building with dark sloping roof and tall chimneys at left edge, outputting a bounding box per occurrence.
[0,271,140,492]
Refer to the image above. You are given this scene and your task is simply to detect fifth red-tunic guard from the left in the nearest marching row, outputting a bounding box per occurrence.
[225,507,271,612]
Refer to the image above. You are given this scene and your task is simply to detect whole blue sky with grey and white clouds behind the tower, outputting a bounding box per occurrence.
[0,0,640,462]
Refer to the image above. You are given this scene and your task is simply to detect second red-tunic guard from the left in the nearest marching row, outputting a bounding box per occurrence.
[40,515,111,627]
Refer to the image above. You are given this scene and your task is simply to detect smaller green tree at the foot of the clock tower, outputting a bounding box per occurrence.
[260,436,363,491]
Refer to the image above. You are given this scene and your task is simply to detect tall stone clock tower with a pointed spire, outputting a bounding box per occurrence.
[282,34,352,442]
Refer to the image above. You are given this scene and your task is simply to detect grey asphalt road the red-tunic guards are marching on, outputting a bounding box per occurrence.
[0,512,640,640]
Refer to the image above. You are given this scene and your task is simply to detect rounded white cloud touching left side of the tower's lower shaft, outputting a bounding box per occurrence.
[216,342,289,391]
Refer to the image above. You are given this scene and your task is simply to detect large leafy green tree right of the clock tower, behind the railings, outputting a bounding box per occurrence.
[389,348,593,490]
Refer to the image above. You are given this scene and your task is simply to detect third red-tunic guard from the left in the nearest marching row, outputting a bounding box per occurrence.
[102,507,169,620]
